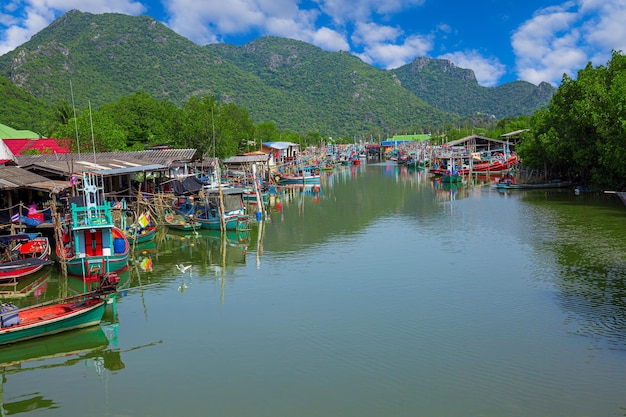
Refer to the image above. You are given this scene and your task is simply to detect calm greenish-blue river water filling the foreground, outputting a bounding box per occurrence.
[0,164,626,417]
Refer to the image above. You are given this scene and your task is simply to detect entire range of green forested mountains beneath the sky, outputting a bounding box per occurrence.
[0,10,547,137]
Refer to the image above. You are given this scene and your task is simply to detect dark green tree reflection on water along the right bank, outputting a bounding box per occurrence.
[518,190,626,350]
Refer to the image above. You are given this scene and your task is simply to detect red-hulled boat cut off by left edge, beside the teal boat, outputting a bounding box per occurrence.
[0,233,52,283]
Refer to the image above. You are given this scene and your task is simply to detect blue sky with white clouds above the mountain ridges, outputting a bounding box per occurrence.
[0,0,626,87]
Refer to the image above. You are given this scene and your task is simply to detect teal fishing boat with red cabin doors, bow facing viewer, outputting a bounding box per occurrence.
[56,173,130,278]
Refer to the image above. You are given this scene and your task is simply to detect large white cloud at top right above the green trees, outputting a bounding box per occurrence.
[511,0,626,85]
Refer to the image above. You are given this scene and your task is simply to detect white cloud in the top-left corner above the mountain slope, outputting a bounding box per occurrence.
[0,0,146,55]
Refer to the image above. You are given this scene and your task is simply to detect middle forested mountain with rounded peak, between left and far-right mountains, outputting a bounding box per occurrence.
[206,37,453,136]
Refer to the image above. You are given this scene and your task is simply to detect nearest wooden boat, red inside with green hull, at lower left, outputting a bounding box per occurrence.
[0,273,119,345]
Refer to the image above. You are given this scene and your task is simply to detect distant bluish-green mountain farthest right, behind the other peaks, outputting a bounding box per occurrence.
[391,57,556,119]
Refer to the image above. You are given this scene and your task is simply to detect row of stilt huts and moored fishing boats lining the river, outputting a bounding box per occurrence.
[0,132,520,295]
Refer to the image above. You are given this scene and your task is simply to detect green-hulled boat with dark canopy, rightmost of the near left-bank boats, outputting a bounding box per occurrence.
[193,188,250,230]
